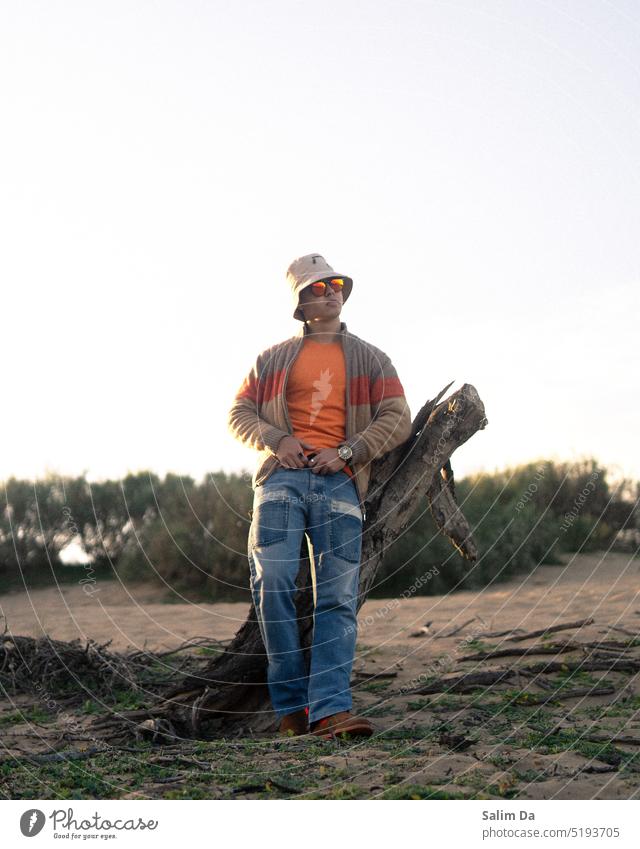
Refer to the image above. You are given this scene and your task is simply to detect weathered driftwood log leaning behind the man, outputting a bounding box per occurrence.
[95,384,487,737]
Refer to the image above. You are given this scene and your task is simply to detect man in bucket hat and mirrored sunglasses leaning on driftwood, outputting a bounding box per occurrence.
[228,254,411,738]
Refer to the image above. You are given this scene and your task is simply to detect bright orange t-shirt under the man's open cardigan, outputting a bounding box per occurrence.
[286,338,353,477]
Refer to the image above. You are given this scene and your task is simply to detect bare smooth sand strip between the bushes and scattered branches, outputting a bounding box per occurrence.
[0,554,640,648]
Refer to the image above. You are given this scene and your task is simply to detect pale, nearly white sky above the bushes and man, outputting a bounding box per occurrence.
[0,0,640,480]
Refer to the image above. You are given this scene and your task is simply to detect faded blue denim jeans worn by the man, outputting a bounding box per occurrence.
[248,468,362,722]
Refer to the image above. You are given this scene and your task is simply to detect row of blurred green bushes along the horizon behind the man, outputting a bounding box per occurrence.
[0,459,640,601]
